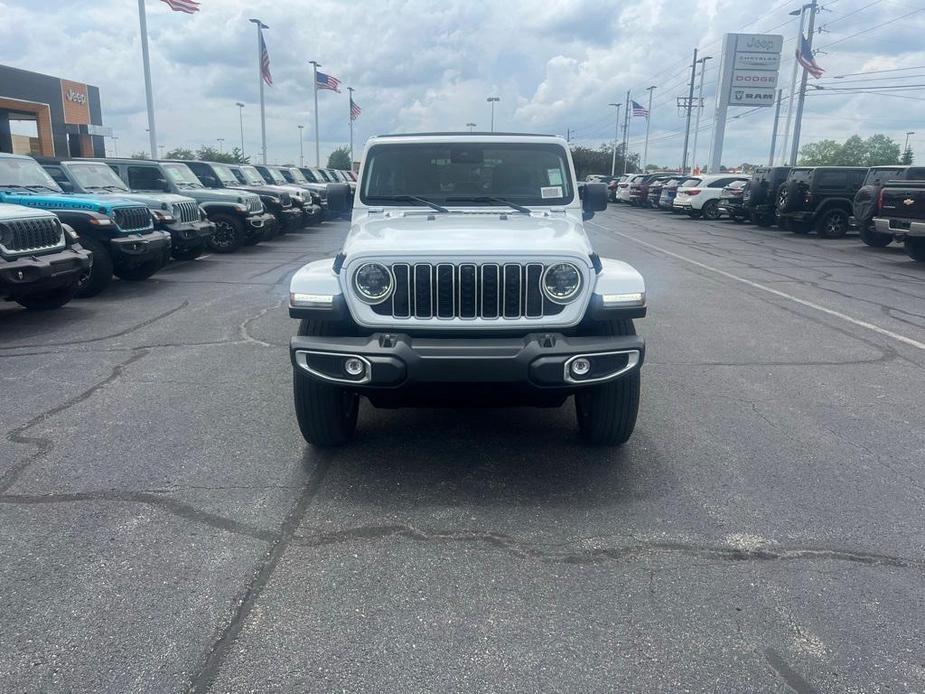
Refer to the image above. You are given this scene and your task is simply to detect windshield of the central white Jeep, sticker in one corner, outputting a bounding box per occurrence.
[361,142,573,205]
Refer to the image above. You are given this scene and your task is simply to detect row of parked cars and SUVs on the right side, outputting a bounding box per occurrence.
[609,165,925,261]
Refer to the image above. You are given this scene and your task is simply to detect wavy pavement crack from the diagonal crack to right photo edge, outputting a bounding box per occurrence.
[292,524,925,570]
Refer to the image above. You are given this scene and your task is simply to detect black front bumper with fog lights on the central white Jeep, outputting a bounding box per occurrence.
[289,333,645,392]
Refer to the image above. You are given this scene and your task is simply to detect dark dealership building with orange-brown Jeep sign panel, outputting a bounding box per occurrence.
[0,65,112,157]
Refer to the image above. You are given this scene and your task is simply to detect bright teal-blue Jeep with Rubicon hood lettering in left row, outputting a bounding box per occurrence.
[0,154,170,297]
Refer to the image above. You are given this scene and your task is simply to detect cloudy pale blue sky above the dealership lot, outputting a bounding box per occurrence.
[0,0,925,167]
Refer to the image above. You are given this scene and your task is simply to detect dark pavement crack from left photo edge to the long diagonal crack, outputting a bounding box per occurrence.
[0,490,275,542]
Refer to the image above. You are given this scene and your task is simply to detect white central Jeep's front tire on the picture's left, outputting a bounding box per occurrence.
[292,320,360,447]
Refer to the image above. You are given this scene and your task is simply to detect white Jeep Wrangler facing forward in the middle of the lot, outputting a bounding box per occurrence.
[289,133,646,446]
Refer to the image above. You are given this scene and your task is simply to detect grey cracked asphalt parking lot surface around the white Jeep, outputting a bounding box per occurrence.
[0,206,925,692]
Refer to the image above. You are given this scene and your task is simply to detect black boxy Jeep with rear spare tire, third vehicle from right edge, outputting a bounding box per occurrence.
[777,166,867,239]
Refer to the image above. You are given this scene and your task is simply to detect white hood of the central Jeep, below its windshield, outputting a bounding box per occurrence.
[344,210,592,259]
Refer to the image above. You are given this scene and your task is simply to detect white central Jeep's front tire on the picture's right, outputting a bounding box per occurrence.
[575,320,640,446]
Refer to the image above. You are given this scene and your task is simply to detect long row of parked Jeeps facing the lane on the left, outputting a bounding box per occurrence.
[0,154,356,316]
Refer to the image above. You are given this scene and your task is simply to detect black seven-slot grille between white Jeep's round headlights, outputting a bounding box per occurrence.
[372,263,565,319]
